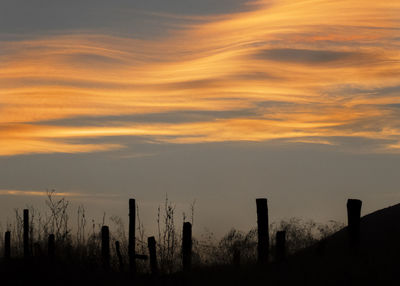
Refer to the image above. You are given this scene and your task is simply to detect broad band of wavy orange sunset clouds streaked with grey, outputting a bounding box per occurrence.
[0,0,400,156]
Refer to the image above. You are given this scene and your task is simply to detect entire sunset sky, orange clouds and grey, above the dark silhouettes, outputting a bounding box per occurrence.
[0,0,400,234]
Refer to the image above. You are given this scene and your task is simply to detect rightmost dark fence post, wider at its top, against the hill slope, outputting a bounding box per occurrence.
[347,199,362,250]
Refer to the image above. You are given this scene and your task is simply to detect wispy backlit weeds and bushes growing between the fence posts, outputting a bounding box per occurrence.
[0,191,343,274]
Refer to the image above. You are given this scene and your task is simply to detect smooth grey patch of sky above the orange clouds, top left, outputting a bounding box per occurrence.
[0,0,253,37]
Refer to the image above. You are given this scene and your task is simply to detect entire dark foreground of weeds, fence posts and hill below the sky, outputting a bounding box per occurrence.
[0,193,400,285]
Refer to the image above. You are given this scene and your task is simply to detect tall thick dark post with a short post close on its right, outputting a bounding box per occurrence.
[256,198,269,264]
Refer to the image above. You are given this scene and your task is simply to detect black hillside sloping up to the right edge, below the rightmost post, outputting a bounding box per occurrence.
[284,204,400,285]
